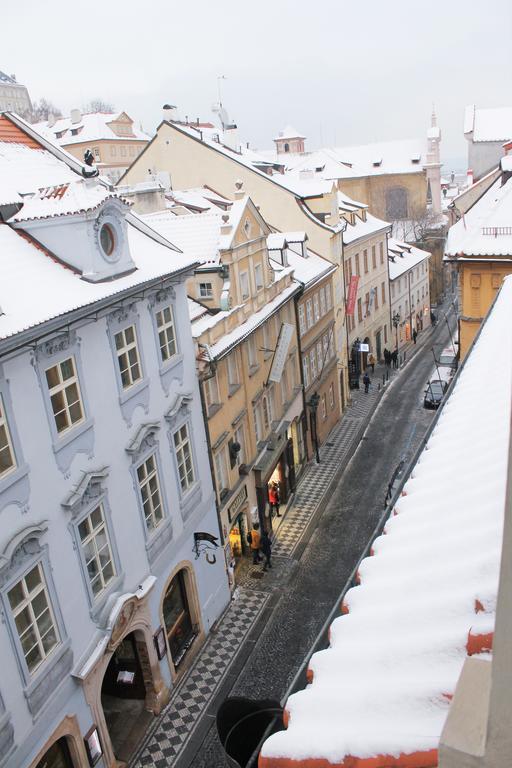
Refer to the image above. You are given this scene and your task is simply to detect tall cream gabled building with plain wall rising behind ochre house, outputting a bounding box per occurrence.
[120,113,348,406]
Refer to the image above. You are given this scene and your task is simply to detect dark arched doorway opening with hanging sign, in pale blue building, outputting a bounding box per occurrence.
[101,631,153,762]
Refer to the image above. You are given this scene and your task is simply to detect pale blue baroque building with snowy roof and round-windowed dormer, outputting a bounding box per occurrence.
[0,114,229,768]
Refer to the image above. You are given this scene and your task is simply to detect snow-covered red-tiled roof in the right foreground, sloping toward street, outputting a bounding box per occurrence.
[259,277,512,768]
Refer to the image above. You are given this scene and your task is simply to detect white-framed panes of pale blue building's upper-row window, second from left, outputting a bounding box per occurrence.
[45,357,84,433]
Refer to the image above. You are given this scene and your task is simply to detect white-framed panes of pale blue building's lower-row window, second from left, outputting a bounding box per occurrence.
[78,504,116,598]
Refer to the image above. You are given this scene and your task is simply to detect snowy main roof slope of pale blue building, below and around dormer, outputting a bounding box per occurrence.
[0,224,196,339]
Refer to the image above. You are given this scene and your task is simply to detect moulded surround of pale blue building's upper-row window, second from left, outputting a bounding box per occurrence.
[32,330,94,474]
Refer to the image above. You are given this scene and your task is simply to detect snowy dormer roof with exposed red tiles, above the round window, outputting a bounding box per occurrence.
[8,182,125,223]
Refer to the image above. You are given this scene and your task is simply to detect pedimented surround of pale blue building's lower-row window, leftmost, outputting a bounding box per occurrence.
[0,521,73,717]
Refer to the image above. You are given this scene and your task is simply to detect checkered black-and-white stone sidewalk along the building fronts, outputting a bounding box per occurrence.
[130,332,434,768]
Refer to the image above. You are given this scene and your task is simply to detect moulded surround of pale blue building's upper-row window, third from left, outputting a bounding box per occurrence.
[107,301,149,424]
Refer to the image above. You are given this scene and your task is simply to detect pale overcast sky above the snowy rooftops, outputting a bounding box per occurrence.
[0,0,512,170]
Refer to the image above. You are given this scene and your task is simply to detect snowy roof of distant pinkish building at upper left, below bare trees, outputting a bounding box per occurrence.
[34,112,151,146]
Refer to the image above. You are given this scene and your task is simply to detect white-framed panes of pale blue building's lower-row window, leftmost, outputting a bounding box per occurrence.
[7,563,60,674]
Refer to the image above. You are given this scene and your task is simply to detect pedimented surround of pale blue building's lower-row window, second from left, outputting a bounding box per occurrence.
[61,466,124,621]
